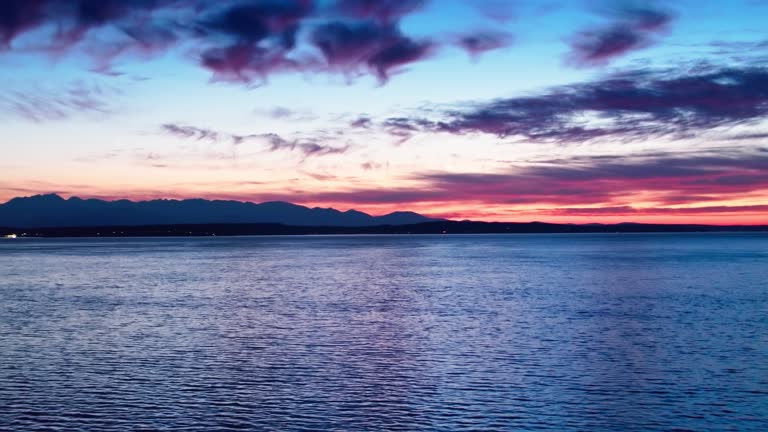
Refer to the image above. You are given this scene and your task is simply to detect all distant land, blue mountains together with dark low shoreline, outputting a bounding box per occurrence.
[0,194,768,237]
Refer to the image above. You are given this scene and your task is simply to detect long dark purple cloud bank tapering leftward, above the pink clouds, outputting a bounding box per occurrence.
[388,68,768,143]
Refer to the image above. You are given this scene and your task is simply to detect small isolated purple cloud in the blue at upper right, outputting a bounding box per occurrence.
[568,1,673,67]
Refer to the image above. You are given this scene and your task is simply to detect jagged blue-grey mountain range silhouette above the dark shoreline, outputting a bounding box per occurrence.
[0,194,441,228]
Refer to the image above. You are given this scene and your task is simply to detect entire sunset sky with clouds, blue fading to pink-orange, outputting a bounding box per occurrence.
[0,0,768,224]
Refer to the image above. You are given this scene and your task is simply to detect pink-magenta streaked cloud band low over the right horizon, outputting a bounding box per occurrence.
[421,148,768,205]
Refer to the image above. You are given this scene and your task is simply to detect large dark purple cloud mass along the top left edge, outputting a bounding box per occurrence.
[0,0,516,86]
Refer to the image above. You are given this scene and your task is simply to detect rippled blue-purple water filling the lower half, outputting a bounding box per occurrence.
[0,233,768,431]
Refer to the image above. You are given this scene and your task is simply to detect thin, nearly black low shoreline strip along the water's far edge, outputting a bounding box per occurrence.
[0,221,768,238]
